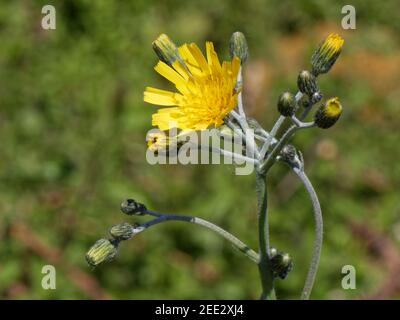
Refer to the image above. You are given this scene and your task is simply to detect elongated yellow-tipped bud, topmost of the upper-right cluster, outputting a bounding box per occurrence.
[311,33,344,75]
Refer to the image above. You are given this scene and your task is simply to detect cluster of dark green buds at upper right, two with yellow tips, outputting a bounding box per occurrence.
[277,34,344,129]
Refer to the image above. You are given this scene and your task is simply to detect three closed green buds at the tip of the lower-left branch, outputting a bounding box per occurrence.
[85,199,147,267]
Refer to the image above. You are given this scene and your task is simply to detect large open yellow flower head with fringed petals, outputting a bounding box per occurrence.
[144,37,240,130]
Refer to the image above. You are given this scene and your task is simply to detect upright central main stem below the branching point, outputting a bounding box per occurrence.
[256,172,275,300]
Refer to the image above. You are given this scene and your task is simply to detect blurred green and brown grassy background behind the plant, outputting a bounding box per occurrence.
[0,0,400,299]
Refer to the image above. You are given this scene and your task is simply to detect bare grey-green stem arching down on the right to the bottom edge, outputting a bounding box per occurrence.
[292,168,323,300]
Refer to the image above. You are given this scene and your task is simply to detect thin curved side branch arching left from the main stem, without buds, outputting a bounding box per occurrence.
[142,210,259,263]
